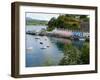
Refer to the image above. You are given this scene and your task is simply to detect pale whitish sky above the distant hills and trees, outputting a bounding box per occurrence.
[26,12,59,21]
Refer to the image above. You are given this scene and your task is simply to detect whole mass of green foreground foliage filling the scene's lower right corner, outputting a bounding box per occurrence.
[59,43,89,65]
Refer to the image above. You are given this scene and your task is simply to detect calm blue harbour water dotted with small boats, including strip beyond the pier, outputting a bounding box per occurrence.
[26,26,83,67]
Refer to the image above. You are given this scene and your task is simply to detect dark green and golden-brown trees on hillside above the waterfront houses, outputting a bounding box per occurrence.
[48,15,89,31]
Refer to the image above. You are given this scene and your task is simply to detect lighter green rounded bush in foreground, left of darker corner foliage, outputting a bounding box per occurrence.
[59,44,80,65]
